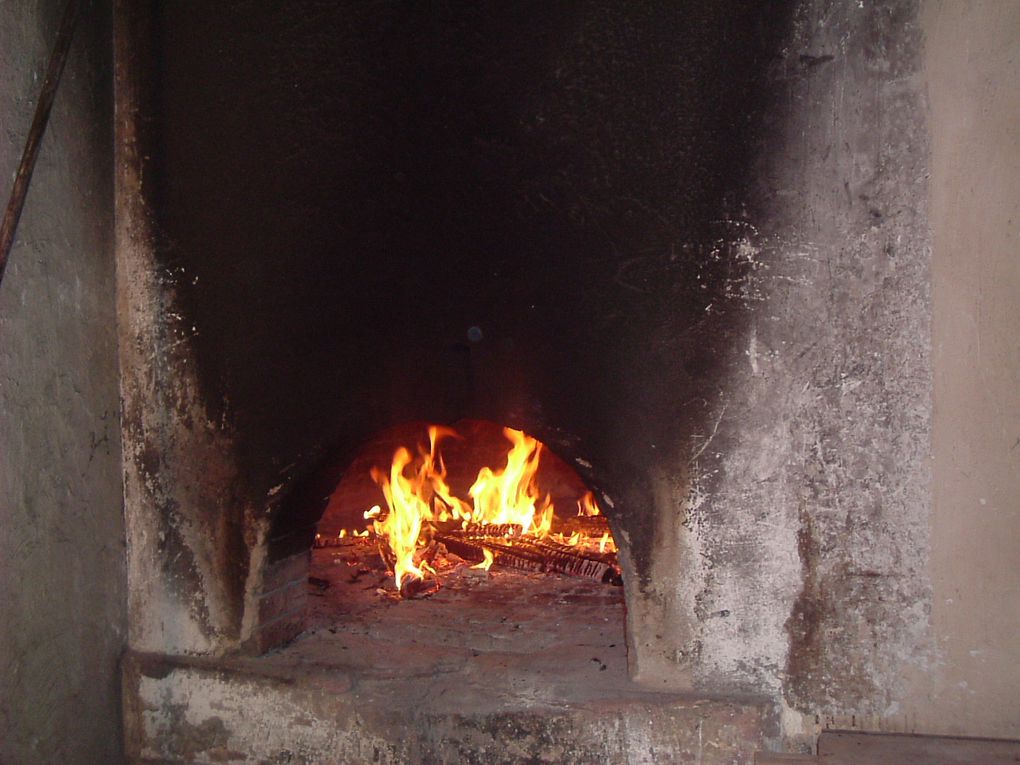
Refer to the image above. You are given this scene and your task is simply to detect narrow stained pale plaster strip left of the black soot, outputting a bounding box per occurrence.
[114,2,262,653]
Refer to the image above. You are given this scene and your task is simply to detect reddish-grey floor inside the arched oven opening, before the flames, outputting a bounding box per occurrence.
[297,545,635,712]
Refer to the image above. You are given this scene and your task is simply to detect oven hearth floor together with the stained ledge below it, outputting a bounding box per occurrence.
[124,548,774,764]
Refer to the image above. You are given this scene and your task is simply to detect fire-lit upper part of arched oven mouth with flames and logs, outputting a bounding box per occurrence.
[314,420,623,599]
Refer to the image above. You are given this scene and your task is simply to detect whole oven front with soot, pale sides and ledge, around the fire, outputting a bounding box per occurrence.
[115,0,930,763]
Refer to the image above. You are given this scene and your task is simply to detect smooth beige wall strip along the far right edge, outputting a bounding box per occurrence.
[903,2,1020,738]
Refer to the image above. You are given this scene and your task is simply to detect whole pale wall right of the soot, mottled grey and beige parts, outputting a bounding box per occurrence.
[673,2,1020,746]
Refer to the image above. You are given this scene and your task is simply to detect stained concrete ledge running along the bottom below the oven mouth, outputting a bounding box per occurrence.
[123,654,775,765]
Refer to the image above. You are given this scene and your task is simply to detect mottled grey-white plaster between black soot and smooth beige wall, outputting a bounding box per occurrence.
[633,2,931,738]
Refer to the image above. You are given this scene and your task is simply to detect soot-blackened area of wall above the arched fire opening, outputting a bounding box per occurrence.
[121,2,788,648]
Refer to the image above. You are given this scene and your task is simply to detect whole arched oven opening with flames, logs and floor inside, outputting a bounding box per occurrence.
[288,420,626,701]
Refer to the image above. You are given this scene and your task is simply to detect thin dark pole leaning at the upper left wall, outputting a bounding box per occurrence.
[0,0,79,284]
